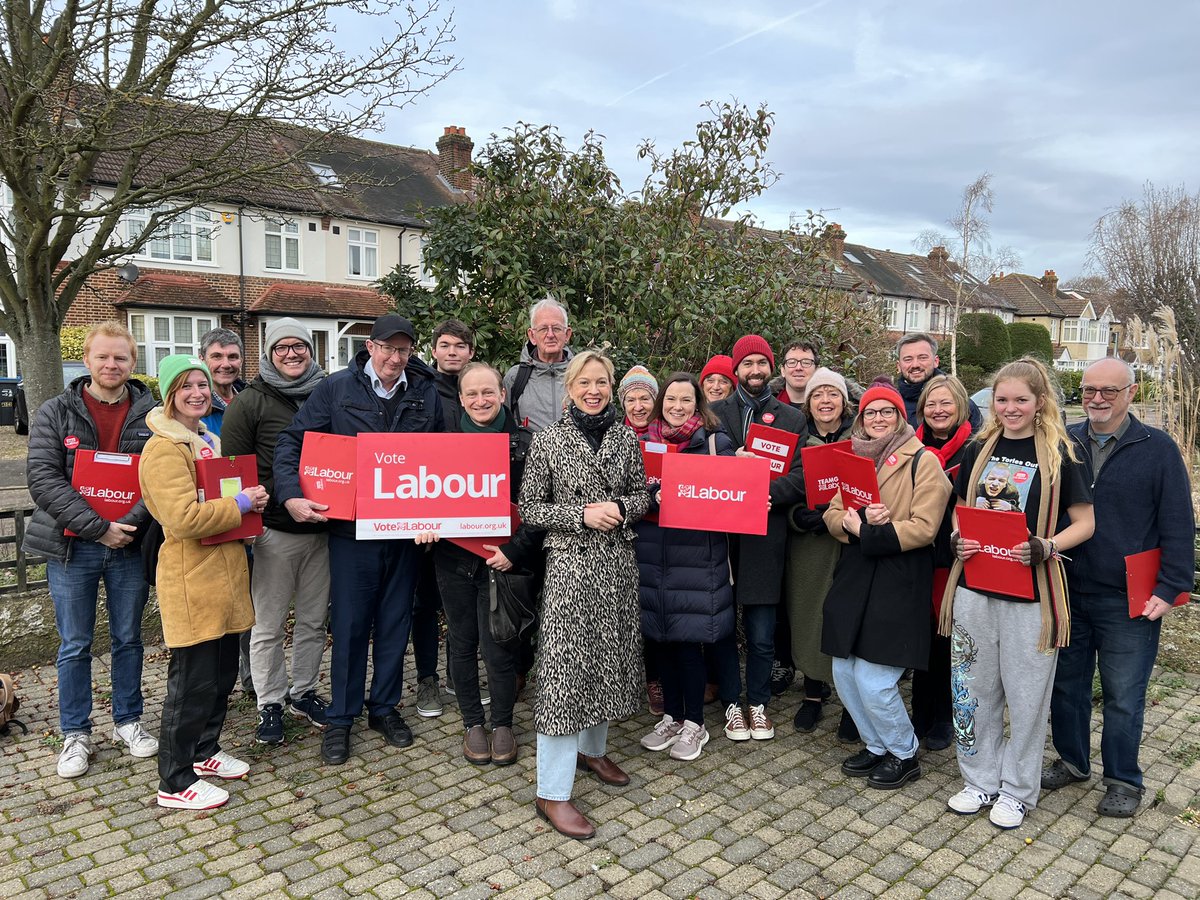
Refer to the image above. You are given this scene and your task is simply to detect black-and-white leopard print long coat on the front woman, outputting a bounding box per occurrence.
[520,418,649,736]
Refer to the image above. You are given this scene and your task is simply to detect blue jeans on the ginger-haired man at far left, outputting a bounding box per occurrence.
[46,538,150,734]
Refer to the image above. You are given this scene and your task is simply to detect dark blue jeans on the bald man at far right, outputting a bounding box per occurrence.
[1050,592,1163,790]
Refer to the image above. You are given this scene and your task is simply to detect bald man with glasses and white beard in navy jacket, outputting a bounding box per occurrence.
[1042,358,1195,818]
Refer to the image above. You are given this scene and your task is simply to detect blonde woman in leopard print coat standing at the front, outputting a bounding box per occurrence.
[520,350,649,838]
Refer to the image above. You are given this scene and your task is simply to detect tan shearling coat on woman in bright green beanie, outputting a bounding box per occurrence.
[138,407,254,647]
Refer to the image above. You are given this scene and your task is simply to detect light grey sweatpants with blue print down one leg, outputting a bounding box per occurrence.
[950,587,1058,809]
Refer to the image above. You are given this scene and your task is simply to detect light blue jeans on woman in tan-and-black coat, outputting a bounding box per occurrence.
[833,656,917,760]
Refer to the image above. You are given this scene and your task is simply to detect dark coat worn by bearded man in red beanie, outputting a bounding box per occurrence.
[713,391,809,606]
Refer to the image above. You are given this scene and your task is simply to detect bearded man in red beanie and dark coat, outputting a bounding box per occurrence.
[713,335,809,740]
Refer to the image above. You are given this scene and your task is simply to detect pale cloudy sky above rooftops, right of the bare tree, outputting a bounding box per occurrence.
[384,0,1200,280]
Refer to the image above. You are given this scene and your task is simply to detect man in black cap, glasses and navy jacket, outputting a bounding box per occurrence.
[274,314,444,766]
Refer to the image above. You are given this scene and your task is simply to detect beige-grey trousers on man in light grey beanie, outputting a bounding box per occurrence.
[250,528,329,709]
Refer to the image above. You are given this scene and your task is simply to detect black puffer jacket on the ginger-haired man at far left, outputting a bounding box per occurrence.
[22,376,157,562]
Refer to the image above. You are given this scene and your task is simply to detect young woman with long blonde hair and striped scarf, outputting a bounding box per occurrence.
[938,356,1096,828]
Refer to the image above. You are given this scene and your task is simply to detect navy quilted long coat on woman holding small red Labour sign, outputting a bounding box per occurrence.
[634,428,733,643]
